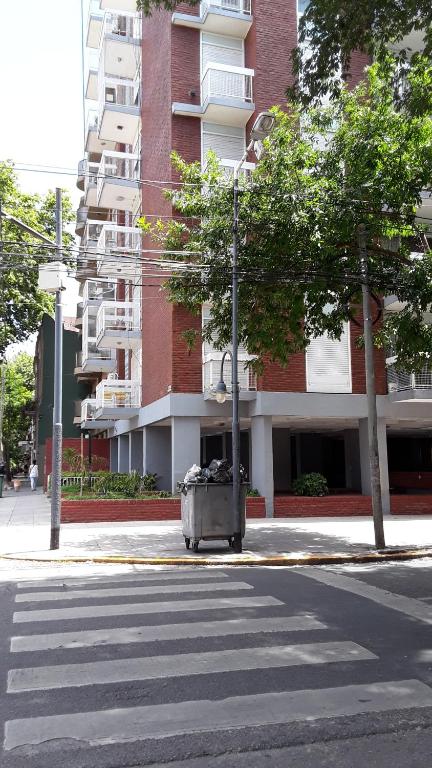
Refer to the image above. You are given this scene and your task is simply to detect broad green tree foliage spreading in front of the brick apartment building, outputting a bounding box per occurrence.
[141,59,432,367]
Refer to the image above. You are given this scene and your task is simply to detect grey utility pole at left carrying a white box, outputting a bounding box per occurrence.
[50,187,63,549]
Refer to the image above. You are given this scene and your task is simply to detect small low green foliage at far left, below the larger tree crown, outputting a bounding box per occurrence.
[3,352,35,466]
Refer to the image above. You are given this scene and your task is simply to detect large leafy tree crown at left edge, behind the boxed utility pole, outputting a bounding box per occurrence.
[0,162,73,358]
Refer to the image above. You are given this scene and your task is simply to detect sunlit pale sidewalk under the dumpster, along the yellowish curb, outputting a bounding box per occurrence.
[0,489,432,564]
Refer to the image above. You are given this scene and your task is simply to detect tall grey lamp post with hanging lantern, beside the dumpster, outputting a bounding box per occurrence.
[216,112,275,552]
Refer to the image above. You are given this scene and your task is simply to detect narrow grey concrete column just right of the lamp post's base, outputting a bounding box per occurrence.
[251,416,274,517]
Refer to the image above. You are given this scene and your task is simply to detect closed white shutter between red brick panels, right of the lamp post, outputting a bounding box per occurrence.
[306,323,352,393]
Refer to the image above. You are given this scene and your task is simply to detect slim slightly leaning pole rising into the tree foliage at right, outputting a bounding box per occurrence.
[357,224,385,549]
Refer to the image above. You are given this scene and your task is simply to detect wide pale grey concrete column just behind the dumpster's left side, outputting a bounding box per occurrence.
[171,416,201,493]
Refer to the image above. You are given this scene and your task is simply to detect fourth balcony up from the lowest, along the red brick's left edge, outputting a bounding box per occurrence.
[97,152,140,211]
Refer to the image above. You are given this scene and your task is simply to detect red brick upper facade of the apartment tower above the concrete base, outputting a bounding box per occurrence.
[141,0,386,405]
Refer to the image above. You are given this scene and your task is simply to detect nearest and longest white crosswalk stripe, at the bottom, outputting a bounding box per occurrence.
[5,680,432,750]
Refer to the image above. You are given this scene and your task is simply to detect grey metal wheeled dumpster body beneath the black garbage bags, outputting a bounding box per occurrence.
[181,483,248,552]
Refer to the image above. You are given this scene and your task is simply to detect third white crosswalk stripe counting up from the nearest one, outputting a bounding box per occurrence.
[11,616,326,653]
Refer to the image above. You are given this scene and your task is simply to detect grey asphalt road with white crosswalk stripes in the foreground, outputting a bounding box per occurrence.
[0,561,432,768]
